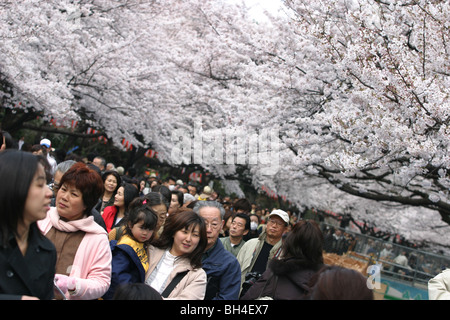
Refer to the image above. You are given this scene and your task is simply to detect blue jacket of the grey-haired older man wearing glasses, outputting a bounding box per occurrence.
[202,239,241,300]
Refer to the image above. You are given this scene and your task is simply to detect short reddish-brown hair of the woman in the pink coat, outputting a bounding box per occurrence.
[60,162,104,216]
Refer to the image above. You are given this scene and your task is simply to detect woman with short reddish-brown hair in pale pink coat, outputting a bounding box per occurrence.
[38,162,112,300]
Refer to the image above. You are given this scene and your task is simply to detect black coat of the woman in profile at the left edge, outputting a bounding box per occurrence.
[0,223,56,300]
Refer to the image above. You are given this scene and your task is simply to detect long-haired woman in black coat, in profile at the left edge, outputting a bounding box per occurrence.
[0,150,56,300]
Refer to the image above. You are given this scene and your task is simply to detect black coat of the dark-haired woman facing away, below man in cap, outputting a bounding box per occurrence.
[242,259,323,300]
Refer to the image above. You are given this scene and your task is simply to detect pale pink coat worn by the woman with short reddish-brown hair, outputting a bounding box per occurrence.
[38,207,112,300]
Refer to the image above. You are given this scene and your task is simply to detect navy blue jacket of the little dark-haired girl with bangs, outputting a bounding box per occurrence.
[103,240,145,300]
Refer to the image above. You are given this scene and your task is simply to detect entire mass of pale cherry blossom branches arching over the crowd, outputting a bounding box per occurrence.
[0,0,450,249]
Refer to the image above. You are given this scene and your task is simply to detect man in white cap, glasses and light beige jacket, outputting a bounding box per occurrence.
[237,210,289,295]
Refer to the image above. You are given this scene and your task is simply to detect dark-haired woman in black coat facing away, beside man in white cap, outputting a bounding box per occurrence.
[242,220,323,300]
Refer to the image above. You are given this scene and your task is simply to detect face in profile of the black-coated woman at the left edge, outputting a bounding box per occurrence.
[23,164,53,223]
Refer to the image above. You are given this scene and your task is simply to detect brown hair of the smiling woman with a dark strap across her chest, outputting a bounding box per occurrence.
[154,210,208,268]
